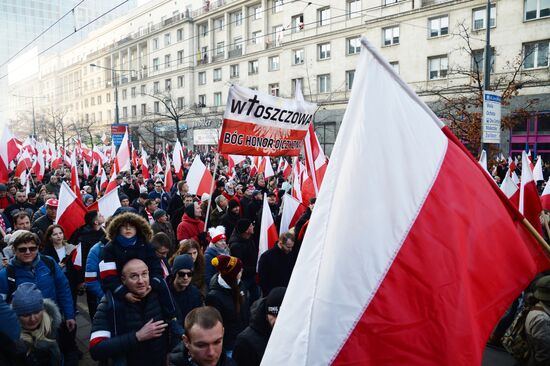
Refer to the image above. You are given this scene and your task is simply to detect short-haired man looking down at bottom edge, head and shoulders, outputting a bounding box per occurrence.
[169,306,236,366]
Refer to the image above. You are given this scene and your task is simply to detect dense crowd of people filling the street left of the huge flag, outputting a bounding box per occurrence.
[0,151,315,365]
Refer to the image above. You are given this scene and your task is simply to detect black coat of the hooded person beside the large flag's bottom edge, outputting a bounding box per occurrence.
[233,297,272,366]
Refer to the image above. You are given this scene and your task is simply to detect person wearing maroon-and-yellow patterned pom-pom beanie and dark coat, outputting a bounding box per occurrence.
[205,255,250,357]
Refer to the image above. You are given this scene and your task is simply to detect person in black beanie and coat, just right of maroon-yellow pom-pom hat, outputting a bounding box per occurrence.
[229,219,260,303]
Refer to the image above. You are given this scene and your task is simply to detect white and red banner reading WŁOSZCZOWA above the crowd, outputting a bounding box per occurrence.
[218,85,317,156]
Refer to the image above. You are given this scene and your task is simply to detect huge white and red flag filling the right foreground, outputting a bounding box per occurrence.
[262,40,550,366]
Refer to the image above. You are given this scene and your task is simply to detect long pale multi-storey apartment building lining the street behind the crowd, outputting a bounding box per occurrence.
[10,0,550,154]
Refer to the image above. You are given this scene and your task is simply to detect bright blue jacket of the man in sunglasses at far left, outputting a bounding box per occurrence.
[0,255,75,320]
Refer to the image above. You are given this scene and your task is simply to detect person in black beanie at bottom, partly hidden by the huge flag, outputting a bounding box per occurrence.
[233,287,286,366]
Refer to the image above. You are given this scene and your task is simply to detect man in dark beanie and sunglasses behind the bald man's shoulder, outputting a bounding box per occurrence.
[168,254,203,346]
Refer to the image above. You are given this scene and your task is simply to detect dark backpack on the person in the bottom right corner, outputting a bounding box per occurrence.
[502,305,544,363]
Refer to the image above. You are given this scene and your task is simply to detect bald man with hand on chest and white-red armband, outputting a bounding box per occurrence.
[90,259,168,366]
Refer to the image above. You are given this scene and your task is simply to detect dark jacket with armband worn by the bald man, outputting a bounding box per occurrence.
[90,291,169,366]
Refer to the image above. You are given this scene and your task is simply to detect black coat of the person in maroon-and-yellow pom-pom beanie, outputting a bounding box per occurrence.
[205,274,250,351]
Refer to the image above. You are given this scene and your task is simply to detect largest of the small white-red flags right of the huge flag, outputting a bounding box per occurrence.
[519,151,542,234]
